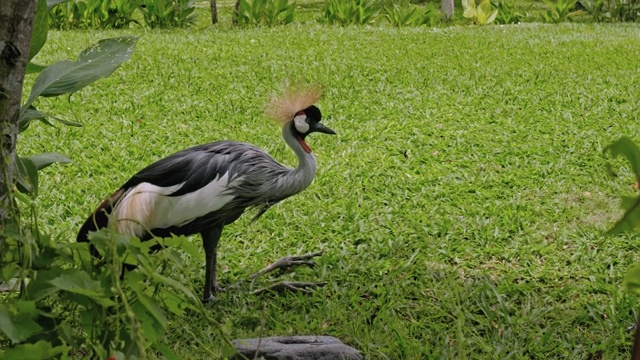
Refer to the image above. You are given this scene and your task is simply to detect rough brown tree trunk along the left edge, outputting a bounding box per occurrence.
[0,0,38,242]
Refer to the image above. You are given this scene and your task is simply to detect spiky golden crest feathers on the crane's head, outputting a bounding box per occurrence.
[266,85,322,124]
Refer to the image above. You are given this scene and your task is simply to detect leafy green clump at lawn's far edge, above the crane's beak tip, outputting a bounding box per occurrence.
[320,0,378,26]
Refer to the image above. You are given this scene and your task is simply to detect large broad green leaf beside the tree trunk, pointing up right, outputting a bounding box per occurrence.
[24,36,138,107]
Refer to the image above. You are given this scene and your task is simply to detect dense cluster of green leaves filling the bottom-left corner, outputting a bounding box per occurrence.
[0,224,216,359]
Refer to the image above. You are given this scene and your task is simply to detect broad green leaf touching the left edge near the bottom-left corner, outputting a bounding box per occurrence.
[0,300,42,344]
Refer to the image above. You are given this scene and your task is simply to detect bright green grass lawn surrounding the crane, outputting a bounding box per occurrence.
[19,7,640,359]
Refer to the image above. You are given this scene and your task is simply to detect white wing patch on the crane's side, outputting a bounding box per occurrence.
[111,174,234,236]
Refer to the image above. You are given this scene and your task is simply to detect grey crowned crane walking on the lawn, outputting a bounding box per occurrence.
[77,87,335,302]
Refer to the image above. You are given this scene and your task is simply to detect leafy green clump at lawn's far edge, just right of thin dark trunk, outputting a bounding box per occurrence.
[236,0,296,26]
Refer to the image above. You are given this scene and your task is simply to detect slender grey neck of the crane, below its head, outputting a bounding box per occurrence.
[282,123,316,195]
